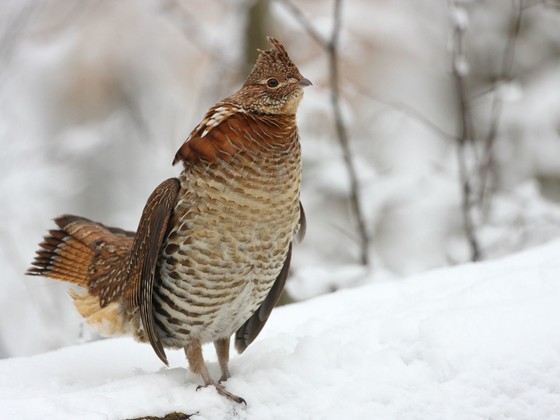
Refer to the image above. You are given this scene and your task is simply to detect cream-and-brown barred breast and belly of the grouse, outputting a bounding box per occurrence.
[154,138,301,347]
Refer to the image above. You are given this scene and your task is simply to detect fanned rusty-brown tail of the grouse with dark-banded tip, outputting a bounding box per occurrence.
[27,215,137,336]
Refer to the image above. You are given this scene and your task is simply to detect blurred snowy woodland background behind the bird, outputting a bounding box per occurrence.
[0,0,560,357]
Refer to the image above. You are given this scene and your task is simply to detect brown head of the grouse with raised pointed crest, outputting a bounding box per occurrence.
[234,37,311,115]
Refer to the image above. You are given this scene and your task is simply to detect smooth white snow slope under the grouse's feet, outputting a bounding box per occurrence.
[0,241,560,420]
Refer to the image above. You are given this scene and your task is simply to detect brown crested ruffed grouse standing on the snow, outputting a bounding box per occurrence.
[26,37,312,404]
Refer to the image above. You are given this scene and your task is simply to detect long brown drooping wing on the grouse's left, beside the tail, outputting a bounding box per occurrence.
[125,178,179,365]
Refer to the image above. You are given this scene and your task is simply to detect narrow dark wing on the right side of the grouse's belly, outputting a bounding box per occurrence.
[235,244,292,353]
